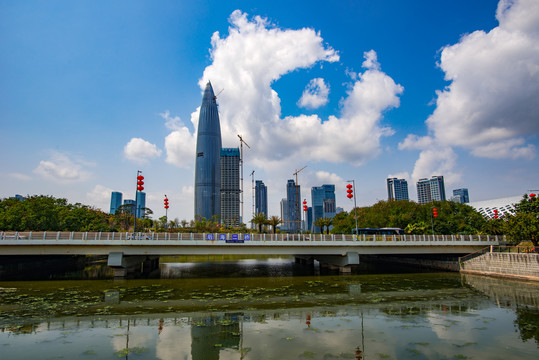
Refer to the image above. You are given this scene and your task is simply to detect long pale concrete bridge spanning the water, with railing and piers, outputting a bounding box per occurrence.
[0,232,504,276]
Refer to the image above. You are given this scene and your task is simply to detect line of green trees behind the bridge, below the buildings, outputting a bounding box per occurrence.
[0,195,539,245]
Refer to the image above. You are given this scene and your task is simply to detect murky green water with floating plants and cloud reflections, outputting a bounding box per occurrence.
[0,259,539,360]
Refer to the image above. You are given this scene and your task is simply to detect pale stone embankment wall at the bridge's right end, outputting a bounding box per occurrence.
[460,253,539,281]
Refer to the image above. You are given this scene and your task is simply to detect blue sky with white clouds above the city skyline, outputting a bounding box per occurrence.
[0,0,539,220]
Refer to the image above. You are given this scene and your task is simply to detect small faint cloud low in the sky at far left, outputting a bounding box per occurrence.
[34,152,90,183]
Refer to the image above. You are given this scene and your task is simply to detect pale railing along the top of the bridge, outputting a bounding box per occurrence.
[0,231,505,243]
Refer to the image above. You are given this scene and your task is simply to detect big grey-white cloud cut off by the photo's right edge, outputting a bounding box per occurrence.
[427,0,539,158]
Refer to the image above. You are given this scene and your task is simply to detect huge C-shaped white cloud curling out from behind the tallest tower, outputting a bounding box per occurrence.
[193,11,403,169]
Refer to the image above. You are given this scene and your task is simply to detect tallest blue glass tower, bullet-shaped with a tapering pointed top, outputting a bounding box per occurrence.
[195,81,221,220]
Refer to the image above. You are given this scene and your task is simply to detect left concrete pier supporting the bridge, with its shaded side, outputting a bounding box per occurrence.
[107,252,159,278]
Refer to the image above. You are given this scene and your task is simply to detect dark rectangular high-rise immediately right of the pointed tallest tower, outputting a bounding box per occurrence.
[221,148,241,226]
